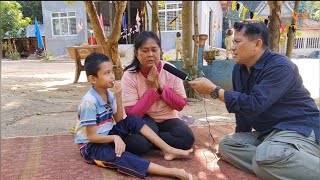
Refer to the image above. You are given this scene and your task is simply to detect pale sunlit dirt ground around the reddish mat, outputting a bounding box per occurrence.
[1,60,319,138]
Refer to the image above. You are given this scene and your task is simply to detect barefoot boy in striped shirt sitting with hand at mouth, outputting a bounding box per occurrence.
[75,53,193,180]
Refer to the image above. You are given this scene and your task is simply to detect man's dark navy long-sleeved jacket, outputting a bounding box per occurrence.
[224,49,320,143]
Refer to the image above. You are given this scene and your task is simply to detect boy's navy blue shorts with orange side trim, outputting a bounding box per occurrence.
[80,116,150,178]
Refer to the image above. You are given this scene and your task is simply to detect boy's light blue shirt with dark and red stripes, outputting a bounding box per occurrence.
[75,86,117,144]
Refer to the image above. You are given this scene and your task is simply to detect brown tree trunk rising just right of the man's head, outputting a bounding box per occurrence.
[268,1,282,52]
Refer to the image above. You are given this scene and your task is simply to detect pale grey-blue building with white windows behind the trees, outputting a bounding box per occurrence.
[42,1,223,57]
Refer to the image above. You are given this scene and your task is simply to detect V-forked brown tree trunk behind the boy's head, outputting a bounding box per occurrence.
[84,1,127,80]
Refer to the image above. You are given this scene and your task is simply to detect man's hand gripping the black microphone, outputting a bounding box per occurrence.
[188,77,216,94]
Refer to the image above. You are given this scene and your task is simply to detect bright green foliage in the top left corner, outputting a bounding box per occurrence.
[0,1,31,38]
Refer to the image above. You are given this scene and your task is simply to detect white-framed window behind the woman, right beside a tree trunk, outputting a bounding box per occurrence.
[158,1,182,31]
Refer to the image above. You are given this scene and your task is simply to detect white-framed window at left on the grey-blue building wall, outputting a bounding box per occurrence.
[51,12,77,36]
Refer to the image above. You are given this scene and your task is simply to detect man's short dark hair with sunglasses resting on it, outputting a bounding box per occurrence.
[233,20,269,47]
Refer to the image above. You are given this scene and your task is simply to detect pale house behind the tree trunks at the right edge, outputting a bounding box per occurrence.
[255,1,320,57]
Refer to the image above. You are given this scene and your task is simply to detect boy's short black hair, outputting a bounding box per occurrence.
[84,52,110,77]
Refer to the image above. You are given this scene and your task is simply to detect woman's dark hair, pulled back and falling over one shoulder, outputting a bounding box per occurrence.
[123,31,161,72]
